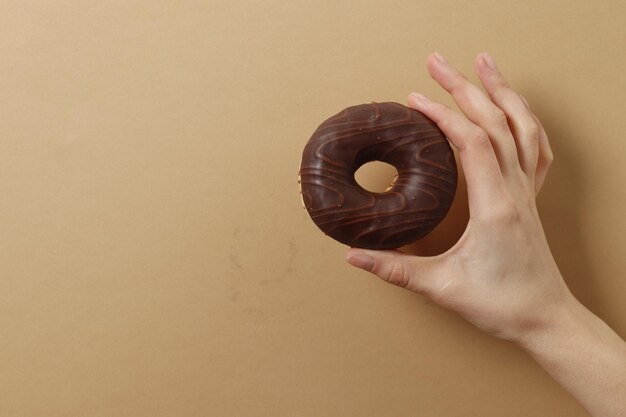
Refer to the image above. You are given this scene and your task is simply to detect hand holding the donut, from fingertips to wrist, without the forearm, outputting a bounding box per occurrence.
[346,53,574,341]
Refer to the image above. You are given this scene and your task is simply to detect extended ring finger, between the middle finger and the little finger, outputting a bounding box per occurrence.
[474,52,539,177]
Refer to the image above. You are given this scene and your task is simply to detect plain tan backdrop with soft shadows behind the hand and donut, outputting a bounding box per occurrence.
[0,0,626,417]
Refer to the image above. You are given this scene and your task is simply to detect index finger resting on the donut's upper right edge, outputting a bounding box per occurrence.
[408,93,505,215]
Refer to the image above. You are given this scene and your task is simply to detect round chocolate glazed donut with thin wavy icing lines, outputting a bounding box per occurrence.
[300,103,457,249]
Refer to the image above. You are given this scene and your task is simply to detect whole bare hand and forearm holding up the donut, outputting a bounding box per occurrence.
[346,53,626,417]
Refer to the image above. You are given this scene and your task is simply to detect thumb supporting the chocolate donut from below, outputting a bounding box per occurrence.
[346,248,435,294]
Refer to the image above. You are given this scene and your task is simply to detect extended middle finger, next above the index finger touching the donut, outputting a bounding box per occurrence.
[427,52,519,177]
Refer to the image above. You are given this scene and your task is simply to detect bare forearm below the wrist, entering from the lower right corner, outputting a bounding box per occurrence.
[518,297,626,417]
